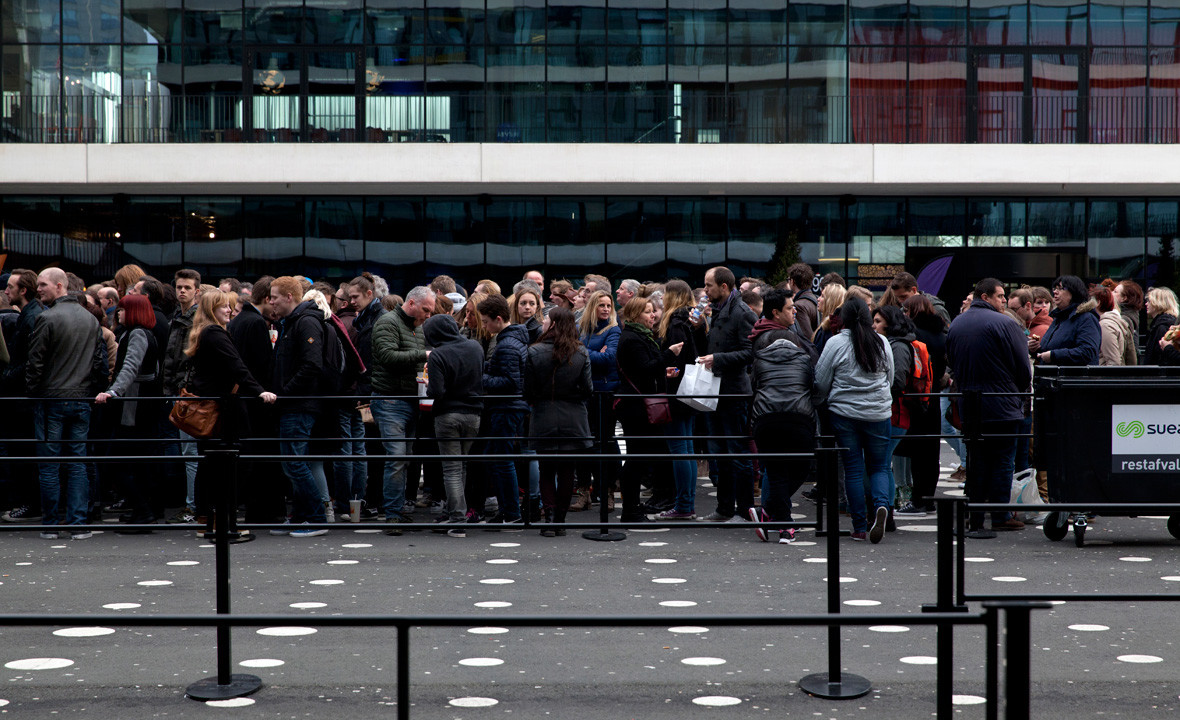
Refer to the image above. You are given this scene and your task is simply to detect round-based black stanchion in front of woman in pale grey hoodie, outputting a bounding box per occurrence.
[799,450,873,700]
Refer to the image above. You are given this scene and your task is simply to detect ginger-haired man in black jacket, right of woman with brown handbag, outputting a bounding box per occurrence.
[270,275,328,537]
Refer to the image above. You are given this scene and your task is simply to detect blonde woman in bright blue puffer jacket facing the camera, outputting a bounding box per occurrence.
[570,290,620,512]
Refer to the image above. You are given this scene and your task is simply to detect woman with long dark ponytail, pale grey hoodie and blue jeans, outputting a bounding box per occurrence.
[815,296,893,543]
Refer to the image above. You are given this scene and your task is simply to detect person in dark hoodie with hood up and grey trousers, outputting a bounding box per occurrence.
[422,315,484,537]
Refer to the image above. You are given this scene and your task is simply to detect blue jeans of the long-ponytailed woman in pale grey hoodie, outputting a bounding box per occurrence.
[832,412,893,532]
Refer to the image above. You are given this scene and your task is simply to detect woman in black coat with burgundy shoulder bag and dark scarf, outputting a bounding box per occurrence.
[615,297,684,523]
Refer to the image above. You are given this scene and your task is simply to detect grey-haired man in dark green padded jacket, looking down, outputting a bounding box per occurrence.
[369,286,434,535]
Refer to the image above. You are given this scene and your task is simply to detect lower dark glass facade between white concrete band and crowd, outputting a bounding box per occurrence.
[0,195,1180,290]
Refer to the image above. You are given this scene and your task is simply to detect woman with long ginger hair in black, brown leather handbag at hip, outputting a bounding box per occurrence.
[184,290,275,530]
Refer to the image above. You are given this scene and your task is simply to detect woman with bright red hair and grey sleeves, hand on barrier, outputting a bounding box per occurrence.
[94,295,164,524]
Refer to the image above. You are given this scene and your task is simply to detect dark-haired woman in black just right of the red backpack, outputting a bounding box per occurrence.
[893,293,946,517]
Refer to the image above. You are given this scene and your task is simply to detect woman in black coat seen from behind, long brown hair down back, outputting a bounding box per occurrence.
[524,308,594,537]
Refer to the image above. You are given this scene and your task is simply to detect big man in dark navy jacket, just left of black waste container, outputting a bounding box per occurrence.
[946,277,1033,538]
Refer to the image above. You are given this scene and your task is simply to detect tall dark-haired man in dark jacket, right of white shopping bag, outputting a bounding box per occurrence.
[696,267,755,523]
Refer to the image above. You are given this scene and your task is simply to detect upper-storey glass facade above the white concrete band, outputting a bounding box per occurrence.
[0,0,1180,143]
